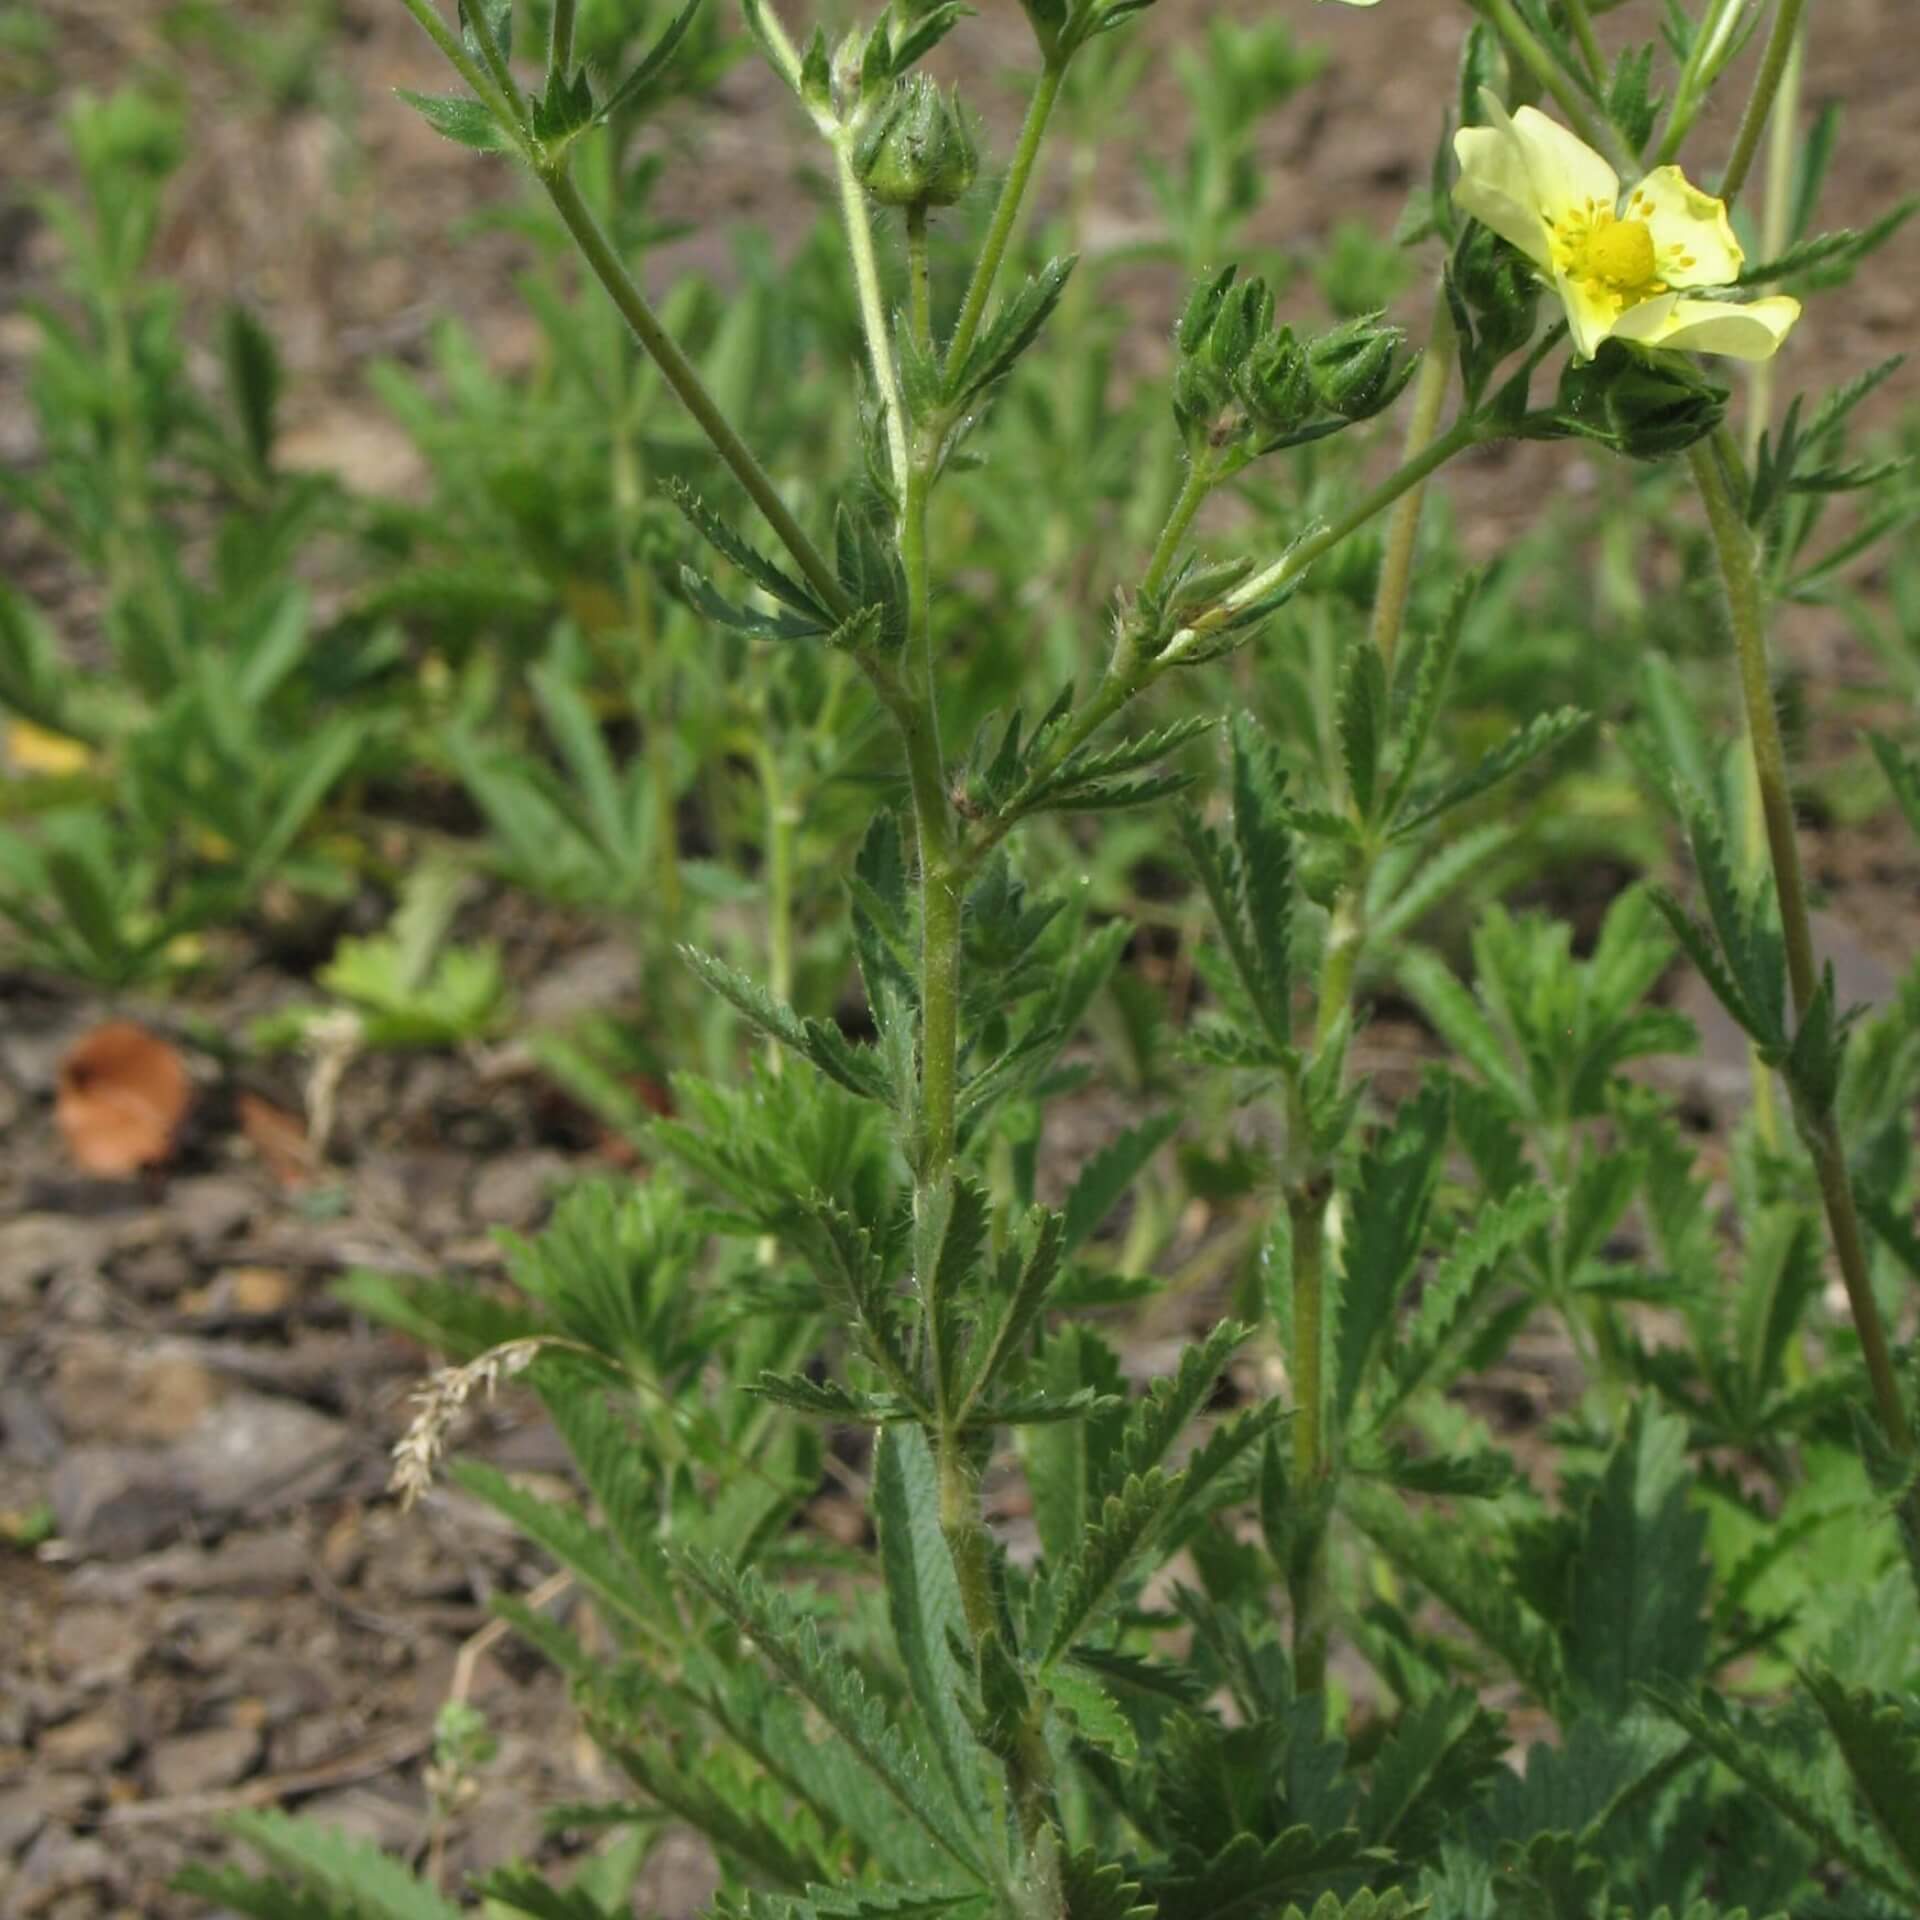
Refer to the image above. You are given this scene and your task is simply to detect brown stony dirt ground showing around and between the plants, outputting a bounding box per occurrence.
[0,0,1920,1920]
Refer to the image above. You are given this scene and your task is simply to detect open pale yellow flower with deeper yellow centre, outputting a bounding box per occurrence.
[1453,96,1799,361]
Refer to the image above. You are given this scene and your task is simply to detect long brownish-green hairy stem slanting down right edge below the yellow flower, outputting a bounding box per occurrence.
[1688,445,1920,1459]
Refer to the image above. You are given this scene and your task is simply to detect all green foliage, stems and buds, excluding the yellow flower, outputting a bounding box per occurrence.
[11,0,1920,1920]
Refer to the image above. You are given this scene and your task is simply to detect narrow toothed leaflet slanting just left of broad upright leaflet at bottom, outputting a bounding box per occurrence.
[678,1553,989,1884]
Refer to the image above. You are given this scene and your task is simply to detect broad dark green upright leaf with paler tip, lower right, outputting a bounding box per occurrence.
[1567,1400,1711,1713]
